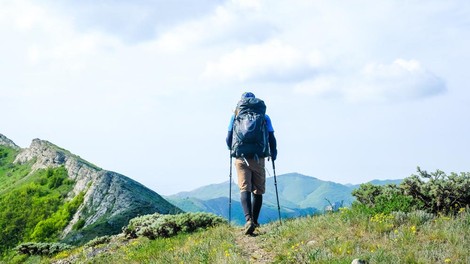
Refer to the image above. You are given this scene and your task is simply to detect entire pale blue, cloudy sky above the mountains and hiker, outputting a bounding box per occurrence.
[0,0,470,195]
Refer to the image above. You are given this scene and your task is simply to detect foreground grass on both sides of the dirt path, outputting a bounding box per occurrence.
[13,208,470,263]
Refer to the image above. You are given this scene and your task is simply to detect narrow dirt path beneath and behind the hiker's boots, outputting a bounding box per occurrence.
[235,228,274,264]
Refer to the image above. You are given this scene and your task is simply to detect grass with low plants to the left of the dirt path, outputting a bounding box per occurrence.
[45,225,246,263]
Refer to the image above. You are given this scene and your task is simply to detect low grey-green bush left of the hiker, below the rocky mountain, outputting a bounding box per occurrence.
[123,213,227,239]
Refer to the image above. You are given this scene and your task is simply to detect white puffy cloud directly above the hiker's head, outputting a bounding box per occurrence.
[202,39,321,82]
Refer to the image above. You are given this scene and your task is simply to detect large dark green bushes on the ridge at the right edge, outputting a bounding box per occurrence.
[352,167,470,214]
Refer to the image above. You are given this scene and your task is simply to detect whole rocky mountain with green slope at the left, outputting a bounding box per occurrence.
[0,134,181,253]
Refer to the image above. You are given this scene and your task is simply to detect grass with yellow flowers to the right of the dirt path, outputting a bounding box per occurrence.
[266,209,470,263]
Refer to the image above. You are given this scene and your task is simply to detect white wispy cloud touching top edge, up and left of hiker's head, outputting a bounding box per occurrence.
[148,1,277,52]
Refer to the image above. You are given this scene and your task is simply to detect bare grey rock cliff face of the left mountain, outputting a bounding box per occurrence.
[5,134,181,243]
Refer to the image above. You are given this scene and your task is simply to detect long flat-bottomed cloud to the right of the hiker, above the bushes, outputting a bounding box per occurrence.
[294,59,446,102]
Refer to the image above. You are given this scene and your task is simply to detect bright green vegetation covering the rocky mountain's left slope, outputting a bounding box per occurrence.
[0,151,83,255]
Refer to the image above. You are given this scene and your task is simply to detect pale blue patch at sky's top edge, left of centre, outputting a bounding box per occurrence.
[48,0,221,44]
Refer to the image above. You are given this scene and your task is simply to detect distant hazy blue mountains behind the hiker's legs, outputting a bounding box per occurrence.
[165,173,353,224]
